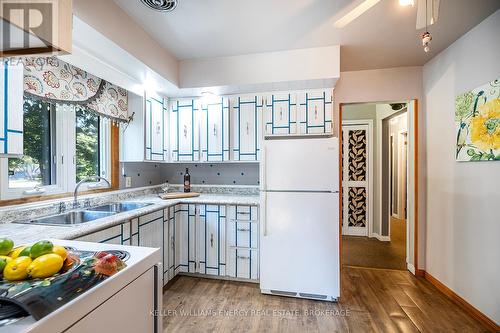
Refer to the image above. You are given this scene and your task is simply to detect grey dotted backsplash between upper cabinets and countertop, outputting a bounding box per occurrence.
[120,162,259,188]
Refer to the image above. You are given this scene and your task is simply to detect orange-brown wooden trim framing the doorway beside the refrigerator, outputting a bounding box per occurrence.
[337,99,418,276]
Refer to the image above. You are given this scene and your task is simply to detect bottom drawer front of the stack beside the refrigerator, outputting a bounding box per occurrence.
[227,247,259,280]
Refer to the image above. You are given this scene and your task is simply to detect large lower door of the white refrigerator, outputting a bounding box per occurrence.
[260,192,340,300]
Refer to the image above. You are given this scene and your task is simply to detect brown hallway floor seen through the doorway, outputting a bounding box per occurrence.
[342,217,406,270]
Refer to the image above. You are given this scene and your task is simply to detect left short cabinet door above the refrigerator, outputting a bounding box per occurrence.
[265,93,297,136]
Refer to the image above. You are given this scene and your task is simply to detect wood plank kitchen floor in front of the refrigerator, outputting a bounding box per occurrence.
[163,267,487,332]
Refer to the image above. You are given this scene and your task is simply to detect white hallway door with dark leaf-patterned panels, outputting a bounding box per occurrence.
[342,122,371,236]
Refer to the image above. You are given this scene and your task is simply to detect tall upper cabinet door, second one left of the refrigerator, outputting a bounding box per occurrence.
[200,97,229,162]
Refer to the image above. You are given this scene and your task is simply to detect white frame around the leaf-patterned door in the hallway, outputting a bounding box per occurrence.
[339,119,374,237]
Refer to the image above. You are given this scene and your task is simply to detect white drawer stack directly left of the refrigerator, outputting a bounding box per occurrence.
[226,205,259,281]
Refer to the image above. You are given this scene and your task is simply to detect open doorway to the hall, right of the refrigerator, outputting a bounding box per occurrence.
[341,101,415,272]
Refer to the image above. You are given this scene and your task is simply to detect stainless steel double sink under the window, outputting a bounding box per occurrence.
[16,202,152,225]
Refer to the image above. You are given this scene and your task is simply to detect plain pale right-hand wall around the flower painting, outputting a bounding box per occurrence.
[423,11,500,324]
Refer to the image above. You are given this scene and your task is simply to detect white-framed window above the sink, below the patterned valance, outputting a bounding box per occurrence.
[0,96,111,200]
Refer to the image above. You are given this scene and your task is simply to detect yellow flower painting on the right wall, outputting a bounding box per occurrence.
[455,79,500,162]
